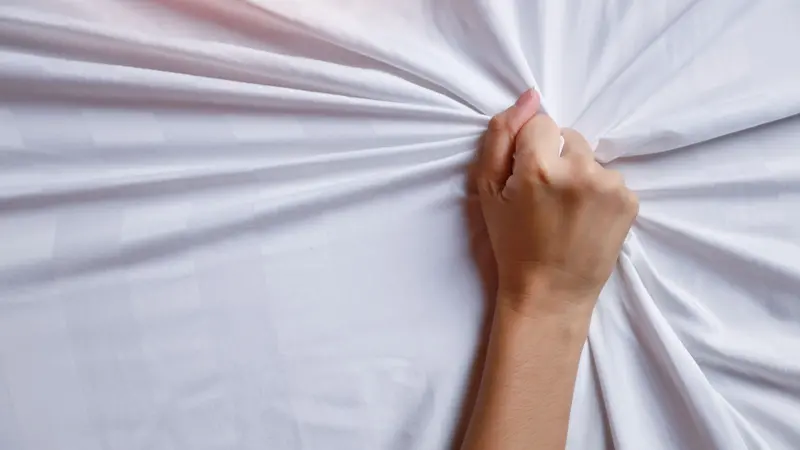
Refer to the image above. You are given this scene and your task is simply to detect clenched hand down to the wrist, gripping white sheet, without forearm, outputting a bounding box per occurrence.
[476,90,639,314]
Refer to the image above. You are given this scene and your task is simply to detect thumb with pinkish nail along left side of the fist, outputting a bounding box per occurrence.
[477,89,540,194]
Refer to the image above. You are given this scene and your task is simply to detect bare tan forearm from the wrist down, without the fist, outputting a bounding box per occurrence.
[462,298,591,450]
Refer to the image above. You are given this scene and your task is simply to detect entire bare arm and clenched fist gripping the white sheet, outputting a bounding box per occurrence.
[462,91,639,450]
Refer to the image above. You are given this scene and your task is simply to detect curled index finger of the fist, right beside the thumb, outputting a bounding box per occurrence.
[515,114,561,168]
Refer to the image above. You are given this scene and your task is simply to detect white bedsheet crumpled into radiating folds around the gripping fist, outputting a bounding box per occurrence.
[0,0,800,450]
